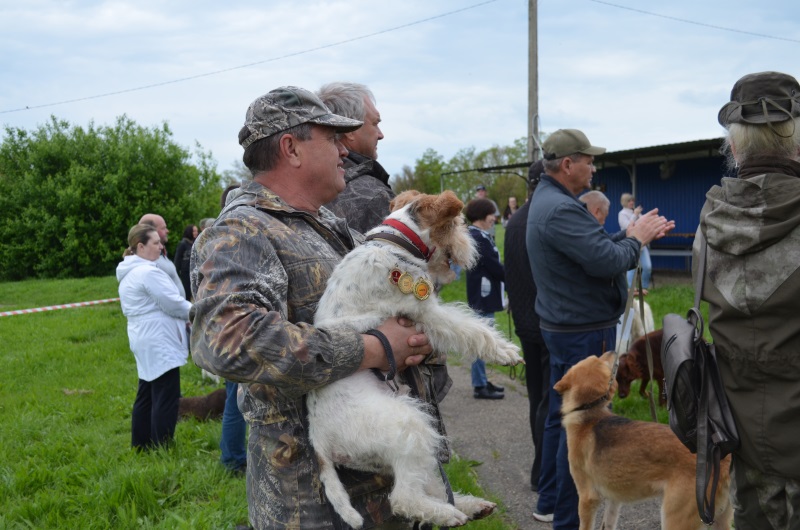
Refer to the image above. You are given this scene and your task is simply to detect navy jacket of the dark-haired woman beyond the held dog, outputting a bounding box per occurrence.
[467,226,505,313]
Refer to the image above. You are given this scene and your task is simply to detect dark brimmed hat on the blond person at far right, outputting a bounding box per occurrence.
[717,72,800,127]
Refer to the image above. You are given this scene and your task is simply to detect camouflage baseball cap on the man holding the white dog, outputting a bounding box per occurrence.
[239,86,363,149]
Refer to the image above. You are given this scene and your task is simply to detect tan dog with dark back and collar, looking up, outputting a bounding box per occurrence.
[554,352,733,530]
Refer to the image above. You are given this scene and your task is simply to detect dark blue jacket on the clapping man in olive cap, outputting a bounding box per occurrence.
[526,175,640,332]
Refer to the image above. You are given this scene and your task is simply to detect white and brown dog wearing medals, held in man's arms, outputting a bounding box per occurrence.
[307,191,523,528]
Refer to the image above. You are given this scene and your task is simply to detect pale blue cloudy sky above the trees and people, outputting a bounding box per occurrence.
[0,0,800,174]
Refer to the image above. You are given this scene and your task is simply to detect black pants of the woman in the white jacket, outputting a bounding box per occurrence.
[131,368,181,449]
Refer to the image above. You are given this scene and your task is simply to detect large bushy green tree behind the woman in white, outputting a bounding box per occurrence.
[0,116,221,280]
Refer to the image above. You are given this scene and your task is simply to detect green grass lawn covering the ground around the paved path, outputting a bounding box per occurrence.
[0,255,692,530]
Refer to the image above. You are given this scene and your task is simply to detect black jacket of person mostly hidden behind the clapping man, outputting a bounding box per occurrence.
[504,201,544,344]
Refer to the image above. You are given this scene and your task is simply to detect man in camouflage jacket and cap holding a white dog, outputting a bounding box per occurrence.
[192,87,431,530]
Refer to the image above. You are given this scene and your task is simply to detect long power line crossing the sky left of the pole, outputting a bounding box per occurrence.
[0,0,498,114]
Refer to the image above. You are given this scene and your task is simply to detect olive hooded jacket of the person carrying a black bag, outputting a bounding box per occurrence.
[694,157,800,480]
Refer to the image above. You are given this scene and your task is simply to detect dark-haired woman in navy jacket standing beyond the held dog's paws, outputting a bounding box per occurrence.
[464,199,505,399]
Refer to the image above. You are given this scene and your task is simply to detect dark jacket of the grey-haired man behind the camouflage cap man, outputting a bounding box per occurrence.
[325,151,395,234]
